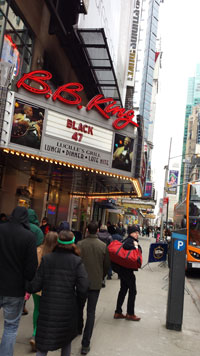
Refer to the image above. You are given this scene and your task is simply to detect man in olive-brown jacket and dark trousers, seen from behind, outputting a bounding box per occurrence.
[77,222,110,355]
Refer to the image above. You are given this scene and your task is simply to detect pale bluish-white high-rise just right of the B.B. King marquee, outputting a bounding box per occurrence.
[133,0,163,195]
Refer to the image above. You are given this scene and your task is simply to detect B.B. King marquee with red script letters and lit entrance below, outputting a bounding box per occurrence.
[0,71,141,230]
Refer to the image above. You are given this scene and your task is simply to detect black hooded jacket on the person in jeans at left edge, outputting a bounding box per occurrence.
[0,206,38,297]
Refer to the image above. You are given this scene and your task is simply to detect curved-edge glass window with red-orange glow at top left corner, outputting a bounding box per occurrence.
[0,2,33,84]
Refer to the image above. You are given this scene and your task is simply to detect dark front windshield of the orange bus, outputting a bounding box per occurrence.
[189,201,200,248]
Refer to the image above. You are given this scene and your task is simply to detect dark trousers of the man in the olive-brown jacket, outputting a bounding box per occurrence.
[81,290,100,347]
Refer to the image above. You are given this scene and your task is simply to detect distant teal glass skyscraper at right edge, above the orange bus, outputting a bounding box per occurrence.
[179,63,200,201]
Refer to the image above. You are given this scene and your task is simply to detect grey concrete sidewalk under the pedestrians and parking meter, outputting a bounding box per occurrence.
[0,237,200,356]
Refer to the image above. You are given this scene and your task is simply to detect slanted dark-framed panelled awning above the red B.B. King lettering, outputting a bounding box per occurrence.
[77,28,122,106]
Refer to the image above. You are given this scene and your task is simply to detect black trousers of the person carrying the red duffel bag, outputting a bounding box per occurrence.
[115,268,137,315]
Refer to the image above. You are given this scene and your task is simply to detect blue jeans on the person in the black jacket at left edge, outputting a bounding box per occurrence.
[0,296,24,356]
